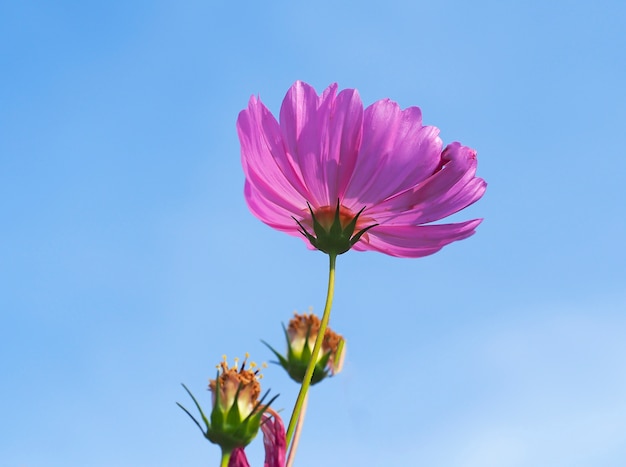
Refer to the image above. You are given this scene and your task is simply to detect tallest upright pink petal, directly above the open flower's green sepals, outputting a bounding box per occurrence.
[280,81,363,207]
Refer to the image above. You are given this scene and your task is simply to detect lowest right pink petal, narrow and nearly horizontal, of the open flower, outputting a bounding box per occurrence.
[354,219,482,258]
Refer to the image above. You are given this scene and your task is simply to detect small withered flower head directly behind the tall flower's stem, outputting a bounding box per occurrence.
[263,313,345,384]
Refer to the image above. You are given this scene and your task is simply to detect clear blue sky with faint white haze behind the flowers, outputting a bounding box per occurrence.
[0,0,626,467]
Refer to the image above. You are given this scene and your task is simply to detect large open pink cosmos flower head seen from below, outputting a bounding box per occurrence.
[237,81,486,258]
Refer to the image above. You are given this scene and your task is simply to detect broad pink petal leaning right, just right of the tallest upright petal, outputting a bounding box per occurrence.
[344,99,442,210]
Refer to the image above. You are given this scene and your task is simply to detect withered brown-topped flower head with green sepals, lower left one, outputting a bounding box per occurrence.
[178,355,278,453]
